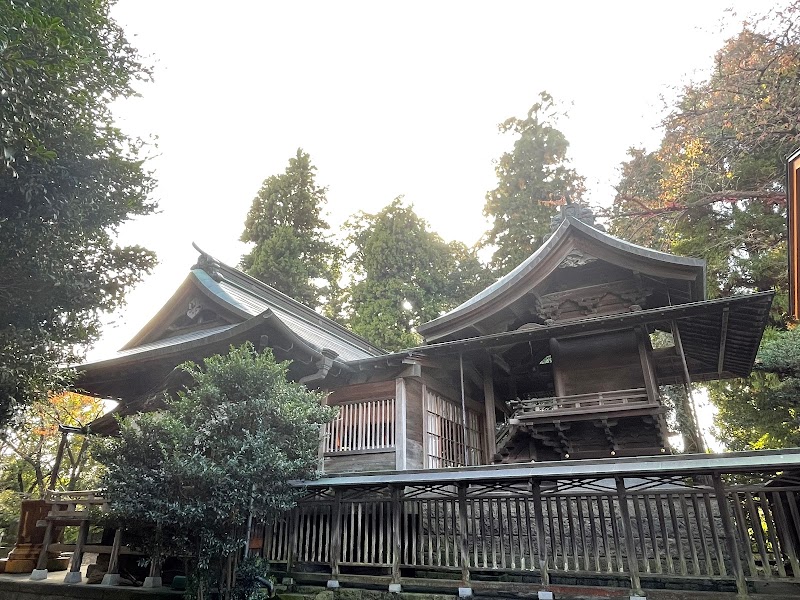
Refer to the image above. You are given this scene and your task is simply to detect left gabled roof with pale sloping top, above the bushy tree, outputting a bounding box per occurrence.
[77,246,386,401]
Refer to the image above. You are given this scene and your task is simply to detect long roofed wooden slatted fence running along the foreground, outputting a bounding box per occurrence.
[264,450,800,593]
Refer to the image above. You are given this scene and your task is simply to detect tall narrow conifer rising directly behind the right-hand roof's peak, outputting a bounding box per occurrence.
[482,92,584,275]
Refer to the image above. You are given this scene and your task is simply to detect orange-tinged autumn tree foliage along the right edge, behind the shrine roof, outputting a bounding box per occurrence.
[612,0,800,449]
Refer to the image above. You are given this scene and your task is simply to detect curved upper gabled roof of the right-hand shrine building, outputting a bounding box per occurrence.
[418,216,705,343]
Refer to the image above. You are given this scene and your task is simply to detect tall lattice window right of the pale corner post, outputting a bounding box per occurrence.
[425,390,483,469]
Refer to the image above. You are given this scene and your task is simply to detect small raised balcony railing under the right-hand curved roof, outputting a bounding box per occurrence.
[508,388,652,419]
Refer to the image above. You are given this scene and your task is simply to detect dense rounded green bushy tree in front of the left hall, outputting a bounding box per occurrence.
[95,344,333,590]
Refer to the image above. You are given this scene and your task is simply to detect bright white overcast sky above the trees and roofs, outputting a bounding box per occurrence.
[89,0,773,359]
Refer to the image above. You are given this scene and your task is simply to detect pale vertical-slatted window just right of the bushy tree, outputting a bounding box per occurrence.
[323,398,395,452]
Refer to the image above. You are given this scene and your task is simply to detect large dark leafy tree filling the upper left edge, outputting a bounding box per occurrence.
[0,0,155,424]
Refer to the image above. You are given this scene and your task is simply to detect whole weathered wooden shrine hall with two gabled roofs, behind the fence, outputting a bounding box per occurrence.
[79,205,773,473]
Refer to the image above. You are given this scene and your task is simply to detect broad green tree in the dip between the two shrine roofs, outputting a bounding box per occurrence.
[343,198,489,350]
